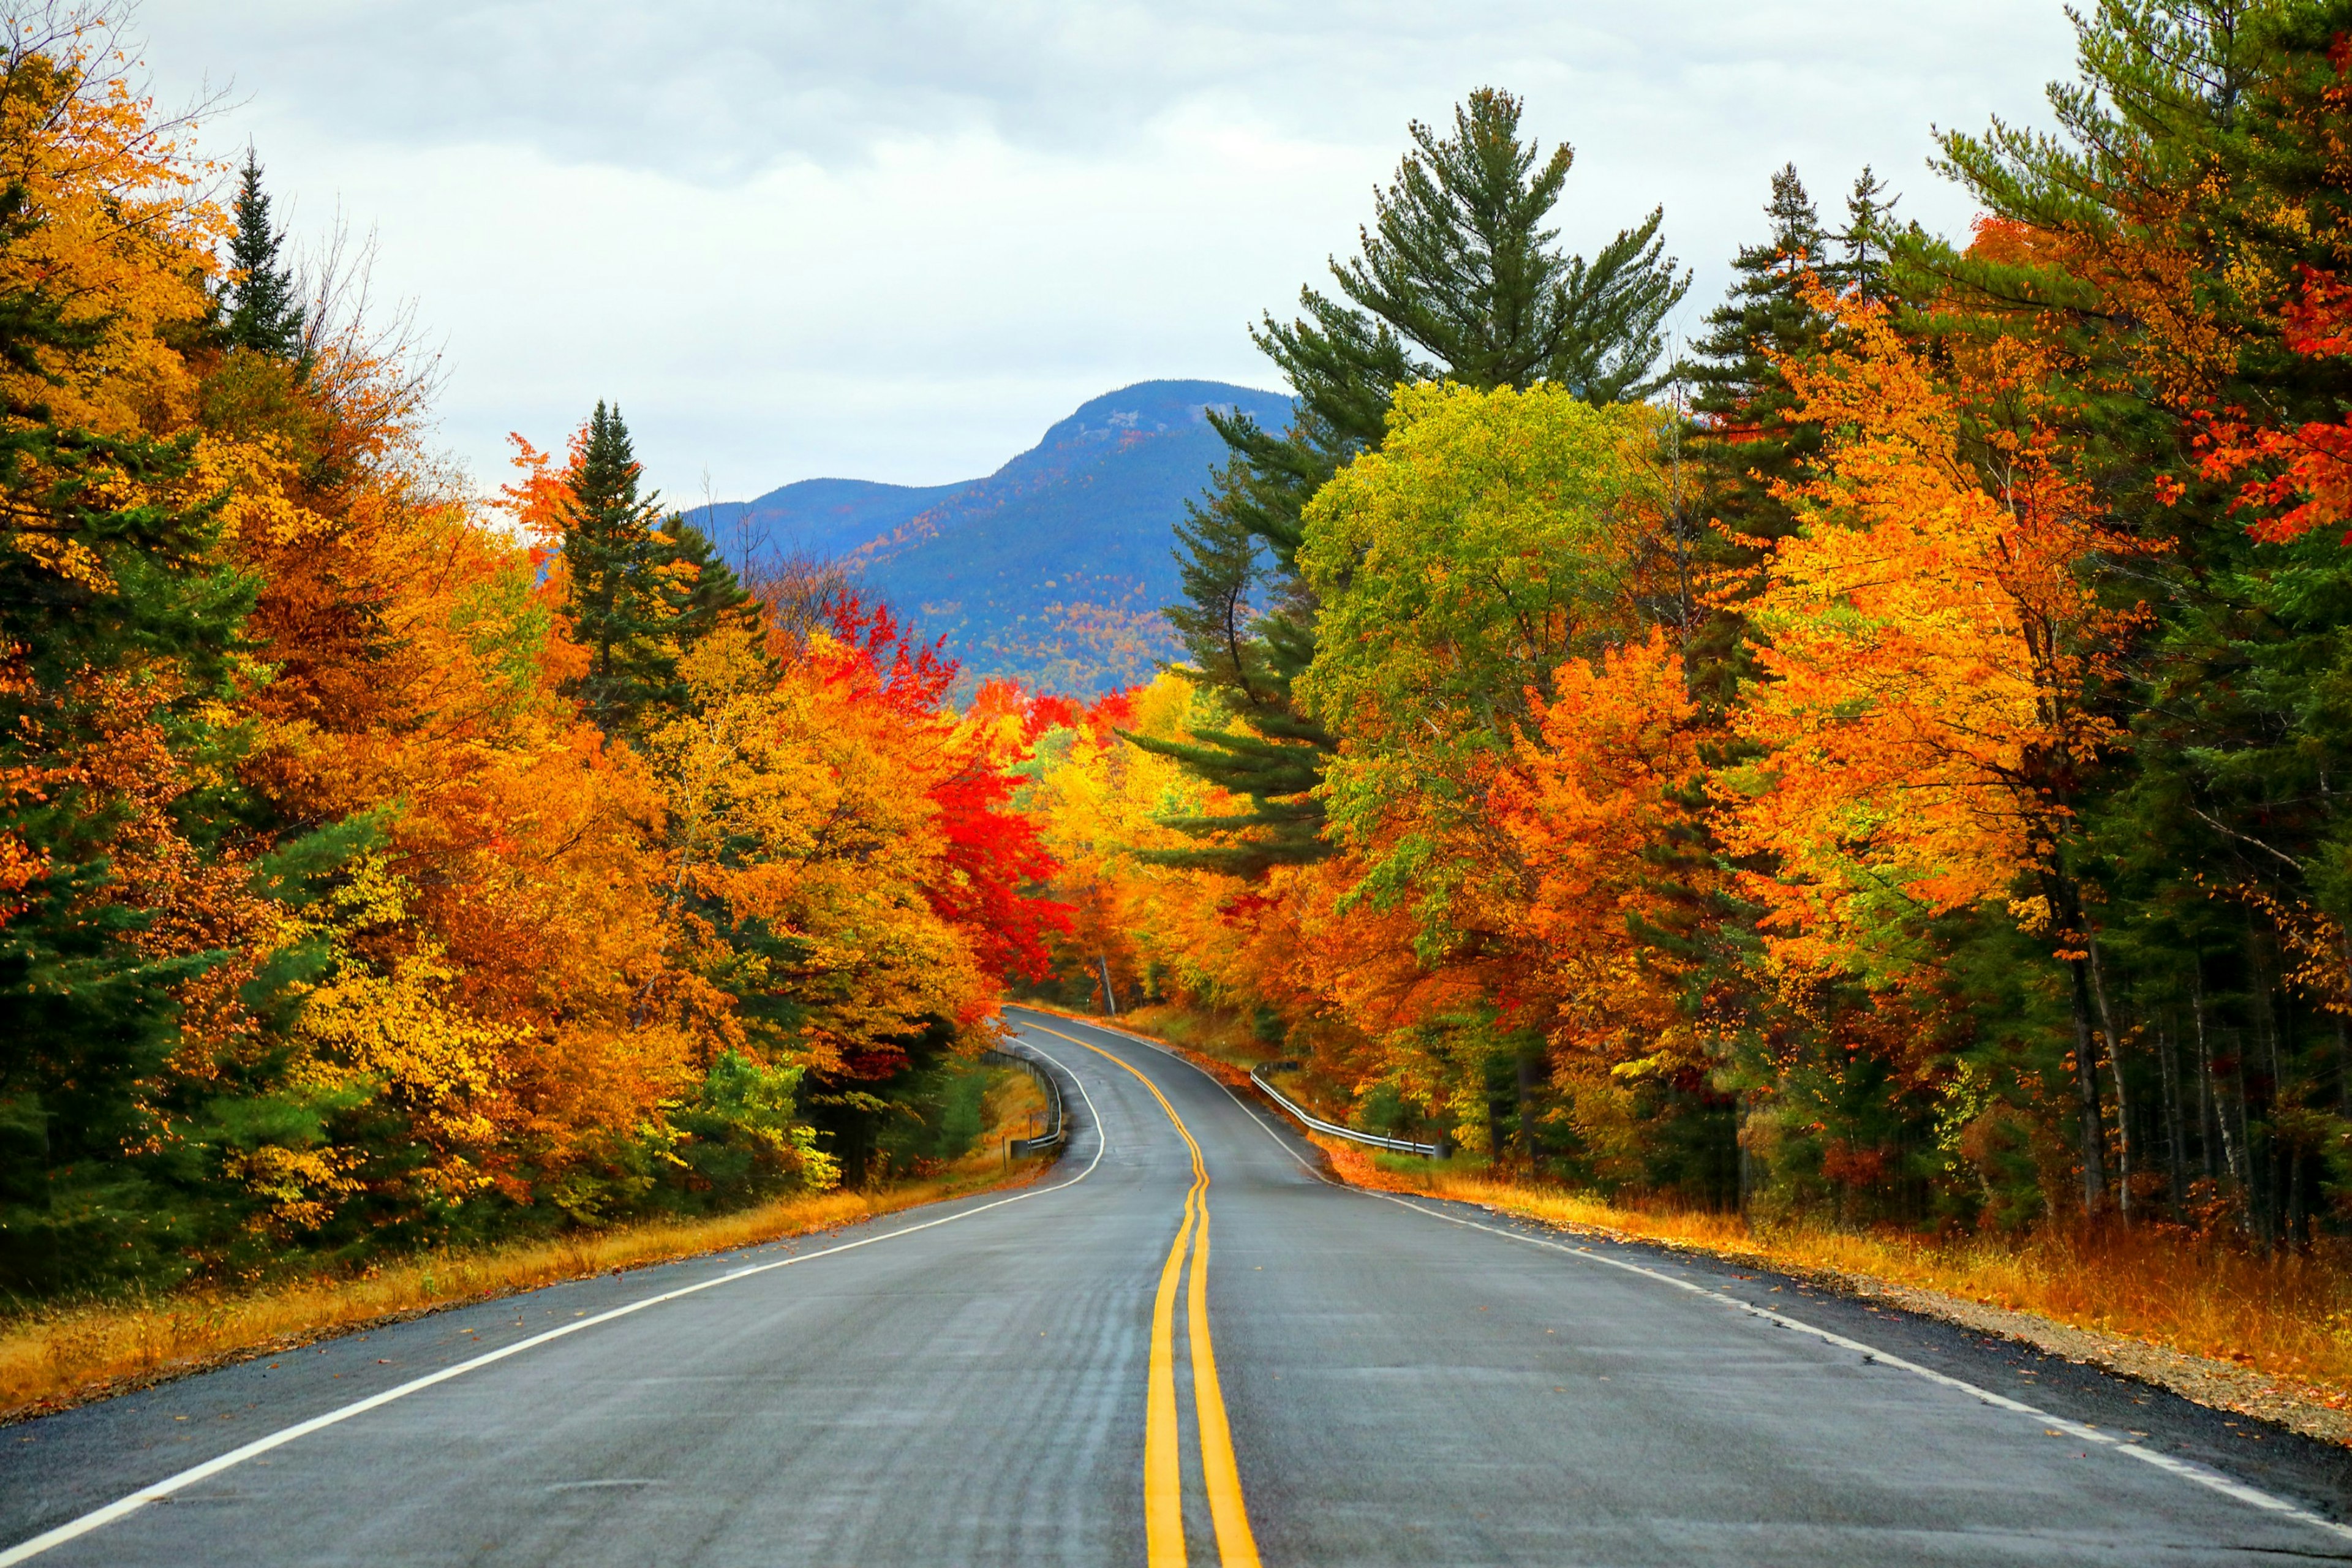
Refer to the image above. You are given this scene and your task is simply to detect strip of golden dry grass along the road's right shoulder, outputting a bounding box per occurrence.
[1315,1138,2352,1411]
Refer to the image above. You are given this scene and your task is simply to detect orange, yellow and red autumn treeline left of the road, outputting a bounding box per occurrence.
[0,12,1063,1295]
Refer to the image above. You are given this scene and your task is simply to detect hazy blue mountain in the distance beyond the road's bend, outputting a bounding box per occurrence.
[694,381,1291,696]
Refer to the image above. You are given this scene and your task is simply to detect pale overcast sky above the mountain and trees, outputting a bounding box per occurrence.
[139,0,2072,503]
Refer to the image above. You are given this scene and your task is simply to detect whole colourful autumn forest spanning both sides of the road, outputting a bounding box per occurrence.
[0,0,2352,1300]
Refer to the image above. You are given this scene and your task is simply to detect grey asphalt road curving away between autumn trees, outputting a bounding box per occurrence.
[0,1013,2352,1568]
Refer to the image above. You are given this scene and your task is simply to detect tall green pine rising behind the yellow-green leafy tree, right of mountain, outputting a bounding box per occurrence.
[1131,87,1689,875]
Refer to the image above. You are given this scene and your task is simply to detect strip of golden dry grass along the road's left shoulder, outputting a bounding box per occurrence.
[0,1072,1044,1422]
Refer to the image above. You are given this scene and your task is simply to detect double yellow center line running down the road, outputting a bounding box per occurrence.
[1021,1023,1258,1568]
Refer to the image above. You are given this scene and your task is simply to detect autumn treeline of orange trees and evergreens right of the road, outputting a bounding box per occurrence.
[1047,0,2352,1243]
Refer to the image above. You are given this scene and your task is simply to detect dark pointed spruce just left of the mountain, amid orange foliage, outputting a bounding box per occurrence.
[565,402,687,733]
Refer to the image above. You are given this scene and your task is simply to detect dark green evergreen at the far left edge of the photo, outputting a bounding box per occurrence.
[0,175,254,1291]
